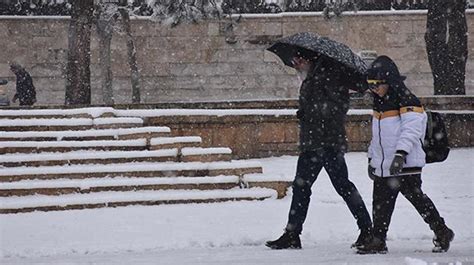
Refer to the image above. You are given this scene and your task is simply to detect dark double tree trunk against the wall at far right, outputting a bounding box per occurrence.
[425,0,468,95]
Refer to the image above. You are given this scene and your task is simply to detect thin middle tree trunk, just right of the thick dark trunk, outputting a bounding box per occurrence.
[97,15,115,105]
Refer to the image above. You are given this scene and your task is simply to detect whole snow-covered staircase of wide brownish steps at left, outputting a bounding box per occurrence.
[0,108,289,213]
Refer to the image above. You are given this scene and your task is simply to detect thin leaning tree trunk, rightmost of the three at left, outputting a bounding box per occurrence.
[119,8,140,103]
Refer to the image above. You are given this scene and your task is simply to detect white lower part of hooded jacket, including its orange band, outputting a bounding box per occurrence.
[368,107,427,177]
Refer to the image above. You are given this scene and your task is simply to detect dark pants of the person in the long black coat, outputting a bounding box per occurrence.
[286,149,372,233]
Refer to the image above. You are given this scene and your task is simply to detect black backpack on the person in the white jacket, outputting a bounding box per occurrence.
[423,110,449,163]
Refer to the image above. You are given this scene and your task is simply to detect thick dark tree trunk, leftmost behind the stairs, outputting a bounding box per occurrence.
[65,0,94,105]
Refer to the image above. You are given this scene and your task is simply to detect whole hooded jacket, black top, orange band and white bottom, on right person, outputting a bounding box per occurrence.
[367,56,427,177]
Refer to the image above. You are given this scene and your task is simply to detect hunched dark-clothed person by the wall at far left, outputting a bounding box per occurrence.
[10,63,36,106]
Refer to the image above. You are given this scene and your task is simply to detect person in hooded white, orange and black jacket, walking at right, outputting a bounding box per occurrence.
[357,56,454,254]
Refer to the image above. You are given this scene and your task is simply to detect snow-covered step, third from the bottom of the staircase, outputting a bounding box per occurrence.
[0,160,262,182]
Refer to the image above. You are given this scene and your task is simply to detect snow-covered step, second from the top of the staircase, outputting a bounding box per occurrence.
[0,117,143,131]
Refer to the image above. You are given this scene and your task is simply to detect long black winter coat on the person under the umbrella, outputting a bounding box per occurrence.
[297,57,351,152]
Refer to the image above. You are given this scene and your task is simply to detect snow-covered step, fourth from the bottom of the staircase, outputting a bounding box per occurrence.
[0,148,179,167]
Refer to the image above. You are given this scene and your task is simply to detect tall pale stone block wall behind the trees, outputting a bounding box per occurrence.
[0,12,474,105]
